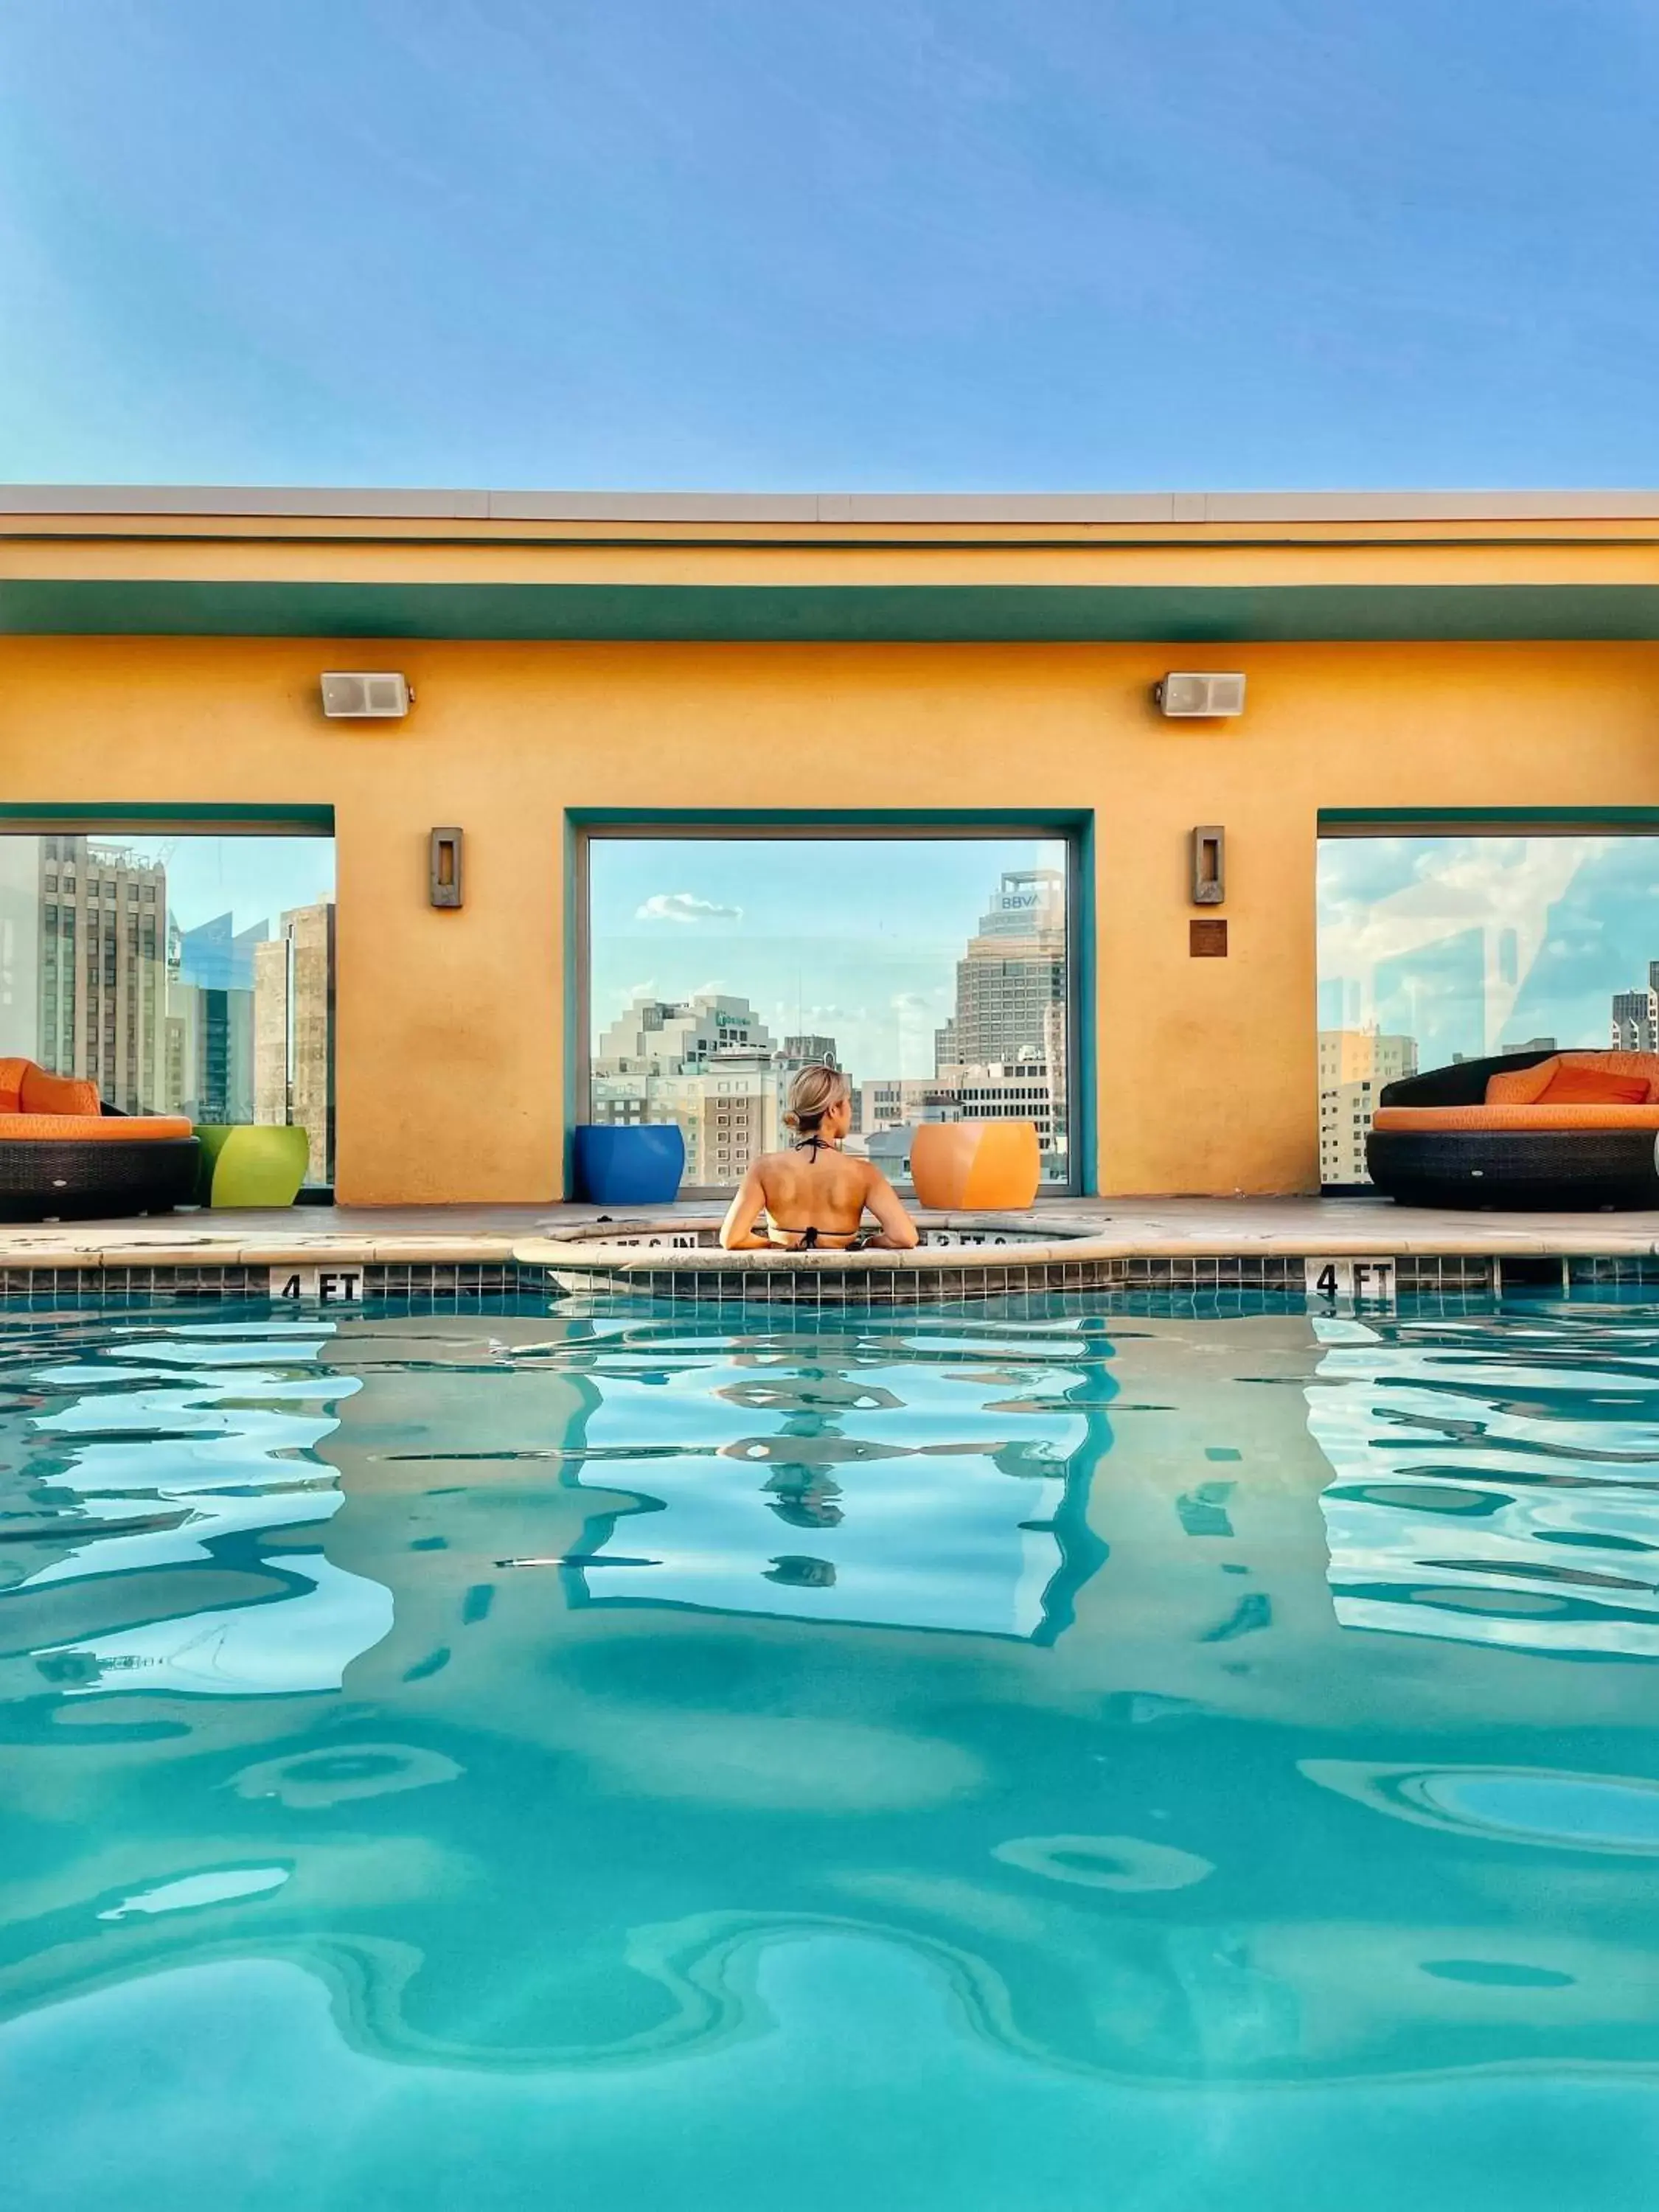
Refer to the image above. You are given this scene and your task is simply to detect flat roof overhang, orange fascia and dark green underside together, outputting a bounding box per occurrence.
[0,487,1659,648]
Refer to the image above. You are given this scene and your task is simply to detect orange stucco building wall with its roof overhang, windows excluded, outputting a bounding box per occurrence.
[0,487,1659,1203]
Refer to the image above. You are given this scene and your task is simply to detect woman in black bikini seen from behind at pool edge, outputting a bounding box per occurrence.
[721,1066,920,1252]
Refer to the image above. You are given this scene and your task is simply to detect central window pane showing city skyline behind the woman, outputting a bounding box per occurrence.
[584,832,1075,1190]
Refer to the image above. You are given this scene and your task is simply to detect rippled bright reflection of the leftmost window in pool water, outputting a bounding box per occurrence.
[0,1323,392,1697]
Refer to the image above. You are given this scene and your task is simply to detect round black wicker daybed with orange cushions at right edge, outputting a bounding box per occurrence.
[1365,1051,1659,1212]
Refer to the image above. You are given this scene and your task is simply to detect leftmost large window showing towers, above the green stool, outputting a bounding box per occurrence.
[0,827,334,1183]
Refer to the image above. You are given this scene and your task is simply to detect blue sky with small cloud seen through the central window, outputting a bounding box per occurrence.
[588,838,1066,1082]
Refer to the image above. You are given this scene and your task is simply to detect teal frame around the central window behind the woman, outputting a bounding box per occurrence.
[580,807,1097,1201]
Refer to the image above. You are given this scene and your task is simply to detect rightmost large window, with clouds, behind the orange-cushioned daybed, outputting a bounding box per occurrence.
[1318,834,1659,1188]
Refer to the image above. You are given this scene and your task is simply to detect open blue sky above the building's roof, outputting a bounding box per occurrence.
[0,0,1659,489]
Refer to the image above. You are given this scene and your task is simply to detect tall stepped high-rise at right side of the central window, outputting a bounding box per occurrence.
[933,867,1066,1073]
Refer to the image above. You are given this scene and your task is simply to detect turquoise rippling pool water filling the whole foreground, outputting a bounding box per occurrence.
[0,1301,1659,2212]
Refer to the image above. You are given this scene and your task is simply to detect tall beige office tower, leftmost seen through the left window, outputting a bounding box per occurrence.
[37,836,166,1113]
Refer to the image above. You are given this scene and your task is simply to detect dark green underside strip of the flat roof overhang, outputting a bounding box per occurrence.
[0,575,1659,646]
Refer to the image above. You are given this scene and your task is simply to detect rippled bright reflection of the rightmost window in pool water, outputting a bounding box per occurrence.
[1307,1310,1659,1659]
